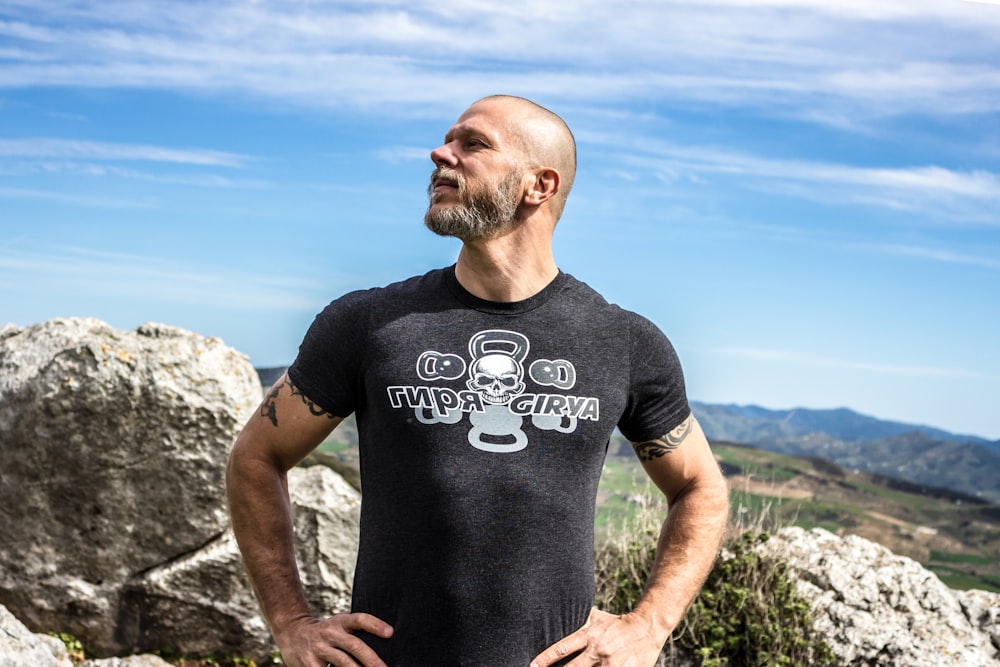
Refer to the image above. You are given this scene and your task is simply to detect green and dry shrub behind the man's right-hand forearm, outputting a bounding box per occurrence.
[595,494,836,667]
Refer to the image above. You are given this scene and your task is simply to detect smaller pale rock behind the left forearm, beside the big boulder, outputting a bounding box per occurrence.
[123,466,361,664]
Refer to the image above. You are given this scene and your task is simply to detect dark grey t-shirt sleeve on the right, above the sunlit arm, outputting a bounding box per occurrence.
[618,313,691,442]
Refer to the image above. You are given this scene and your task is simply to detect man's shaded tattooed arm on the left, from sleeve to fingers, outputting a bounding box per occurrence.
[226,375,392,667]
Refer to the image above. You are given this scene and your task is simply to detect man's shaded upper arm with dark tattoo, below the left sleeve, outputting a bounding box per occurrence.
[233,374,343,470]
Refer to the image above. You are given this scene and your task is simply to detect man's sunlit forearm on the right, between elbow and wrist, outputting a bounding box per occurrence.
[633,476,729,642]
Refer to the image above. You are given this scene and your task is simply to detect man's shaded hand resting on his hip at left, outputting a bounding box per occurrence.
[278,614,392,667]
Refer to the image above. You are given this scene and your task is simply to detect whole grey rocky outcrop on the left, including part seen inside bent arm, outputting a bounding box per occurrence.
[0,318,359,667]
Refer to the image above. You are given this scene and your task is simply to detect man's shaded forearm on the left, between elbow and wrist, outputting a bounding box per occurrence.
[226,444,311,644]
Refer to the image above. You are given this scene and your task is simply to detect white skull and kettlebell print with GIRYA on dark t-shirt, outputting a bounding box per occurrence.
[386,329,600,453]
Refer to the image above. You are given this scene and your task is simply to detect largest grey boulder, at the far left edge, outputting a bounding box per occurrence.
[0,318,261,655]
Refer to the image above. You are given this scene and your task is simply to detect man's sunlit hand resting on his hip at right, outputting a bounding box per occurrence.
[531,609,664,667]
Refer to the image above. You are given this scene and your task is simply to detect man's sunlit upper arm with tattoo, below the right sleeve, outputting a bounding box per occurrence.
[632,414,722,502]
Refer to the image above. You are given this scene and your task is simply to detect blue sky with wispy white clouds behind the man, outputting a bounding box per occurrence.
[0,0,1000,439]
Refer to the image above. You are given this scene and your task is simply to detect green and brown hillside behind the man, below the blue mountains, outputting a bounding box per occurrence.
[596,443,1000,592]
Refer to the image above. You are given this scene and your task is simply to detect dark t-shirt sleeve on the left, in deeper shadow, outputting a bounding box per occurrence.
[288,290,375,417]
